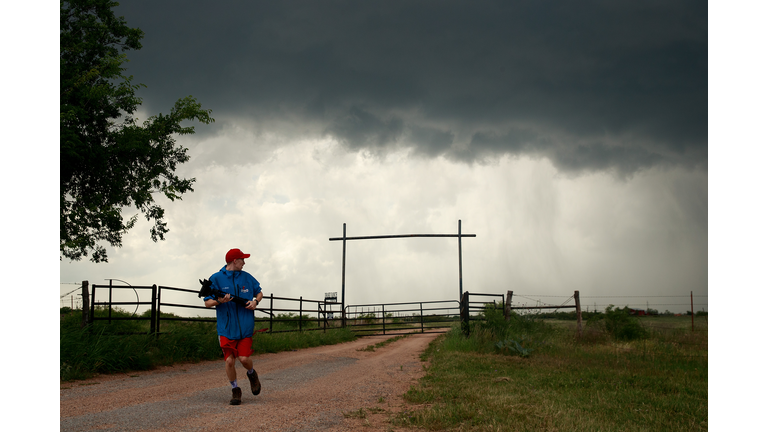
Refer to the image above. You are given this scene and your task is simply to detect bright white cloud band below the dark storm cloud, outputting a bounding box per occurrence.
[60,131,707,316]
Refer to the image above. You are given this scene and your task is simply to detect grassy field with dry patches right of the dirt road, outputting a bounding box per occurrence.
[390,308,707,431]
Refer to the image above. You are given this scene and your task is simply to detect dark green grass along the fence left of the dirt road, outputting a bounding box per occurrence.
[59,308,356,381]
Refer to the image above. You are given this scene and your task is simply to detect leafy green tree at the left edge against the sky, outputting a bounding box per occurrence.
[59,0,213,262]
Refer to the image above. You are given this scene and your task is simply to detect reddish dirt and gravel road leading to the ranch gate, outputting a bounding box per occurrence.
[60,333,438,432]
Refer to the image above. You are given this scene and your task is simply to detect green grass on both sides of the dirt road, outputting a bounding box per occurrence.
[61,308,708,431]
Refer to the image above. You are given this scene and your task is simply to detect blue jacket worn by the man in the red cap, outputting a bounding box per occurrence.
[204,266,261,340]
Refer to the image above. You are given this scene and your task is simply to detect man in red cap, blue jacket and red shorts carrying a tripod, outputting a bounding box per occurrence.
[204,249,263,405]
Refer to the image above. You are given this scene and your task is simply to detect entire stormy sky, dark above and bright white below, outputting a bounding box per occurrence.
[55,0,709,318]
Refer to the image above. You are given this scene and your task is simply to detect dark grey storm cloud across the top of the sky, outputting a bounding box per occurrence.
[118,0,707,173]
